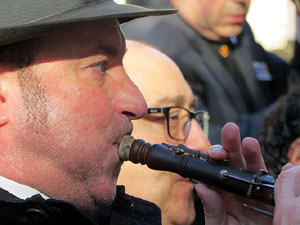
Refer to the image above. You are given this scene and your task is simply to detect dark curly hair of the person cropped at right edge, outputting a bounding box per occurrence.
[260,87,300,176]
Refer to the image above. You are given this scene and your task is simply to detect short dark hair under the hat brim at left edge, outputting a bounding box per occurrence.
[0,38,41,69]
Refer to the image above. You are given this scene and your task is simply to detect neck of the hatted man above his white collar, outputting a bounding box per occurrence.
[0,147,97,212]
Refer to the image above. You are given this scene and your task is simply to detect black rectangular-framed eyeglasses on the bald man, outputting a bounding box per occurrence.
[148,106,209,141]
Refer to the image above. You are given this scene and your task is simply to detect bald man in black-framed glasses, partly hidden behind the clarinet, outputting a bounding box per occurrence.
[118,41,210,225]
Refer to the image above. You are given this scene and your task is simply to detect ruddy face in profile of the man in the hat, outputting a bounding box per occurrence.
[11,20,146,210]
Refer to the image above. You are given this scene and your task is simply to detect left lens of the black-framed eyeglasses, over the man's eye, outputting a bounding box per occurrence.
[168,108,190,140]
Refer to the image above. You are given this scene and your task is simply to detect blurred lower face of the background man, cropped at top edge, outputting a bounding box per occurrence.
[188,0,250,41]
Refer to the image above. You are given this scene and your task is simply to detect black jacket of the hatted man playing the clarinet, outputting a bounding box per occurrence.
[0,187,161,225]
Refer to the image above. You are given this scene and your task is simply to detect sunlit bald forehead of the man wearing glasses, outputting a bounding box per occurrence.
[124,42,193,107]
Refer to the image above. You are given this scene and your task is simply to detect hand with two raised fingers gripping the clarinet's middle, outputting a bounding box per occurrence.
[195,123,272,225]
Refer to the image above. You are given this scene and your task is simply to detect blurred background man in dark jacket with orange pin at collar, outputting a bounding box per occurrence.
[123,0,299,144]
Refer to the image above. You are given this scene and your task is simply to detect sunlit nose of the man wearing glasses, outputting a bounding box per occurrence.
[185,119,210,152]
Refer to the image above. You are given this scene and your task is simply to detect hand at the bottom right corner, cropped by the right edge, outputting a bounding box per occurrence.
[273,163,300,225]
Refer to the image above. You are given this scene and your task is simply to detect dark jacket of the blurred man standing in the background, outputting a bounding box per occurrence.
[122,15,289,144]
